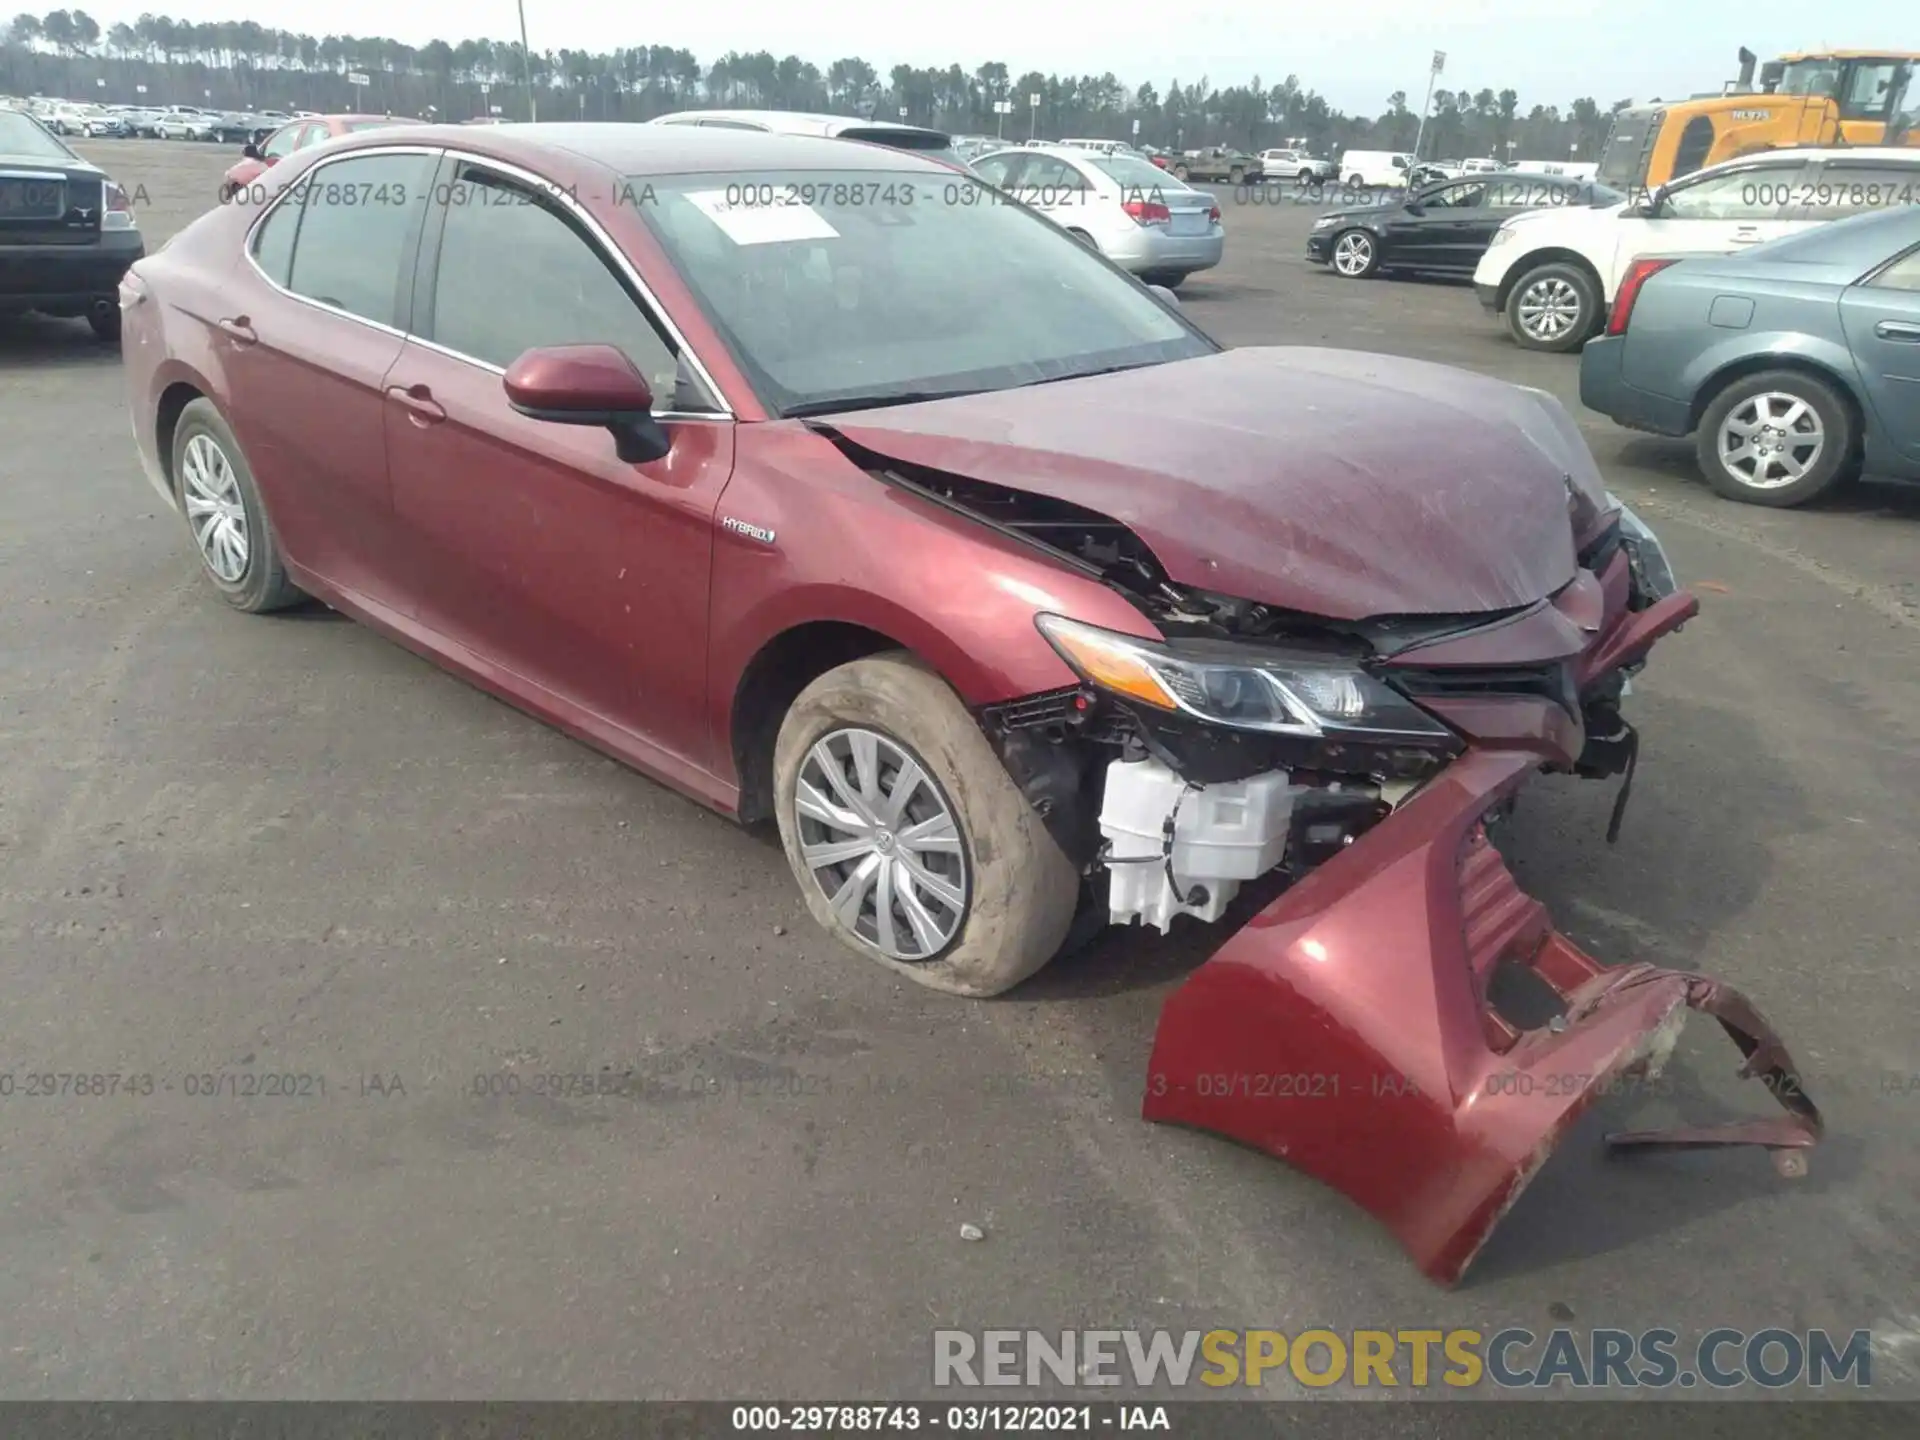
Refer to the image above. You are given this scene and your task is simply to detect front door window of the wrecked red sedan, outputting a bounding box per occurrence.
[426,165,695,409]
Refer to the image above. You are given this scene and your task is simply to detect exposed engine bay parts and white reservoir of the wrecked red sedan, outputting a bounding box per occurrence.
[870,457,1645,931]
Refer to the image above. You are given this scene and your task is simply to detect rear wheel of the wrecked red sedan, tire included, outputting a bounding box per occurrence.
[173,399,303,614]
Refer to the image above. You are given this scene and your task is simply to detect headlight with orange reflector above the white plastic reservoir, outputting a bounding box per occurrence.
[1035,614,1452,739]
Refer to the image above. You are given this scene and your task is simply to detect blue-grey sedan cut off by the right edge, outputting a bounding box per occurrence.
[1580,205,1920,505]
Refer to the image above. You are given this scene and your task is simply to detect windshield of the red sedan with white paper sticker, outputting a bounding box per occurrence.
[628,171,1217,415]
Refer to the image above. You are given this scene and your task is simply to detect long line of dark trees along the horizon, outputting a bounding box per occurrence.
[0,10,1626,159]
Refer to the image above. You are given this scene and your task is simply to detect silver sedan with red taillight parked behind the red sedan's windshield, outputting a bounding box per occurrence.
[973,146,1227,290]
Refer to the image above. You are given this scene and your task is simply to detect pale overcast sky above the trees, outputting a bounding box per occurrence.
[67,0,1896,113]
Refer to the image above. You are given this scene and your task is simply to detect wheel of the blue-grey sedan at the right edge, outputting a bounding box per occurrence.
[1695,371,1855,507]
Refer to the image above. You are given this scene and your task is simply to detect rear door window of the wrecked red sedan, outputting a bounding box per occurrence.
[275,156,434,326]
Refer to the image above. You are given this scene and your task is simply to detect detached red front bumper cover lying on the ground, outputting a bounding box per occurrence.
[1144,751,1822,1284]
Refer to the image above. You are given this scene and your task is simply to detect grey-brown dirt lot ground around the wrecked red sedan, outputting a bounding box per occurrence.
[0,142,1920,1398]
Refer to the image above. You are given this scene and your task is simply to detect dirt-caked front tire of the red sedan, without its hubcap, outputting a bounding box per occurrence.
[774,651,1081,996]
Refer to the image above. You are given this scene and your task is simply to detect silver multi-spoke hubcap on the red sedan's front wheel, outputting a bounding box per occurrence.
[793,730,968,962]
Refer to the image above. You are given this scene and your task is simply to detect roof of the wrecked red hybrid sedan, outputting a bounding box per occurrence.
[328,121,954,177]
